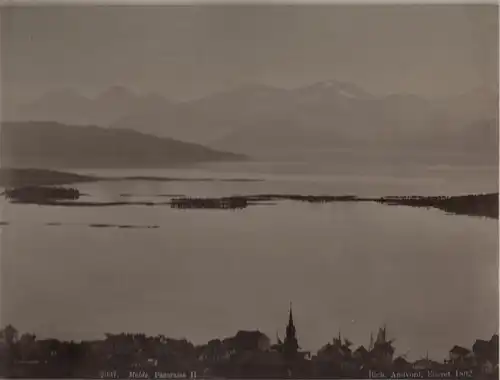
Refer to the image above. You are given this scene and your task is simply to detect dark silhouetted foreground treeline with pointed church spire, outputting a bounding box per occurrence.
[0,309,498,379]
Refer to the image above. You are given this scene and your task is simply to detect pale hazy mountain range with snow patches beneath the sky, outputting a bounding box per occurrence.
[4,81,498,162]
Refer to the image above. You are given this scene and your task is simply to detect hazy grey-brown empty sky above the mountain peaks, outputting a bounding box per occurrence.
[1,4,498,105]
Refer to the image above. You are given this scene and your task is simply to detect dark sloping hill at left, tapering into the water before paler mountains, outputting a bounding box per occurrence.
[0,122,245,168]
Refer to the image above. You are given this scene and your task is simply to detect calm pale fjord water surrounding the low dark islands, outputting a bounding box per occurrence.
[1,163,498,360]
